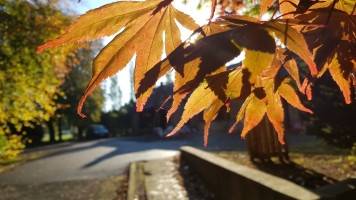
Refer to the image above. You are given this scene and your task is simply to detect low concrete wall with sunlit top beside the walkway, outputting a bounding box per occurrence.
[181,147,321,200]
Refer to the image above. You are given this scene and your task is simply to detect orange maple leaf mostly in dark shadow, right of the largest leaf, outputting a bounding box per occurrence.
[138,23,245,121]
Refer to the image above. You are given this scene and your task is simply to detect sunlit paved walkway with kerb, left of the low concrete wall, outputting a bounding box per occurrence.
[127,156,215,200]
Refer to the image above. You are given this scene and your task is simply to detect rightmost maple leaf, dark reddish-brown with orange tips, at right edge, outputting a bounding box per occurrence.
[298,8,356,103]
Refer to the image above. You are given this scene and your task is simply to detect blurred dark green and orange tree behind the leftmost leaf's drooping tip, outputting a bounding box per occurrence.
[57,41,104,139]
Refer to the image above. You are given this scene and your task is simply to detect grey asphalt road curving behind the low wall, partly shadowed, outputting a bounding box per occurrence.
[0,135,245,185]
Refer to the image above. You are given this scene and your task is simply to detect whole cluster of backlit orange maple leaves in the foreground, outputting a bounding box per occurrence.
[37,0,356,144]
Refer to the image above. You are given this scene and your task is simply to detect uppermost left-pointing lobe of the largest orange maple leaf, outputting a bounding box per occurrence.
[37,0,162,52]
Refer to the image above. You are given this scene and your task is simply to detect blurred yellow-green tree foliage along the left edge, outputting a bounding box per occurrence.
[0,0,72,159]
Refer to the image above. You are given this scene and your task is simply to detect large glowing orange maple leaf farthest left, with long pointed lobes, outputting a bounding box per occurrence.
[38,0,198,117]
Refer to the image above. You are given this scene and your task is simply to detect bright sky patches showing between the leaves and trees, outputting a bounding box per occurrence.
[65,0,210,111]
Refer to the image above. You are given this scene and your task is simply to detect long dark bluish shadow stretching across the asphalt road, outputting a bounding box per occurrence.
[39,135,246,169]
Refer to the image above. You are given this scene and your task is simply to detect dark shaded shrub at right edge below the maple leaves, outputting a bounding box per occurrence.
[302,73,356,147]
